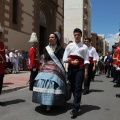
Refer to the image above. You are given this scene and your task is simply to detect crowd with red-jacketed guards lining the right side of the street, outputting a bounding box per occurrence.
[92,41,120,98]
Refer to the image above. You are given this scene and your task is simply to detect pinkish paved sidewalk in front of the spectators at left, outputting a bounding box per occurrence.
[2,71,30,93]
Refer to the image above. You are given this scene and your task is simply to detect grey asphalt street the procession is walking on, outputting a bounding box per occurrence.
[0,75,120,120]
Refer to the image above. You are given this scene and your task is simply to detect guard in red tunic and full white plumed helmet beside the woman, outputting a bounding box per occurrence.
[29,32,40,91]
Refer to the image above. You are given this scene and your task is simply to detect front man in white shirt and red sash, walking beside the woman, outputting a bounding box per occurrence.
[63,28,89,117]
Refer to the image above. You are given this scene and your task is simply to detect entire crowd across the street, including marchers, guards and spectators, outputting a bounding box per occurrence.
[0,28,120,117]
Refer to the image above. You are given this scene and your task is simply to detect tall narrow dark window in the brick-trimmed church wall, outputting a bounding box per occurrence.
[12,0,18,24]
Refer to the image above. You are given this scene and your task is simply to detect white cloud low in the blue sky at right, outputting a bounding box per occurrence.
[106,33,119,49]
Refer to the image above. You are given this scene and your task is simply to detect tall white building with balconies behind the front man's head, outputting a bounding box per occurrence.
[64,0,91,43]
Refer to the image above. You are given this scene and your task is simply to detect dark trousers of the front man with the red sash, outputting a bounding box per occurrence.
[68,66,85,110]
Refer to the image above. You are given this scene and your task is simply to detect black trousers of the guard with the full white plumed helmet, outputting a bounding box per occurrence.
[29,69,38,91]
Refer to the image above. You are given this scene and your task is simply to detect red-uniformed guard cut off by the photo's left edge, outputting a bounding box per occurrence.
[0,29,6,105]
